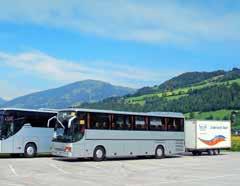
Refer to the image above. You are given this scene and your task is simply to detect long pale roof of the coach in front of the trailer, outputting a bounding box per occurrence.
[59,108,184,118]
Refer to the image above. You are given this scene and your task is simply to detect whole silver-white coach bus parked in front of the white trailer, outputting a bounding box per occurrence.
[52,109,185,161]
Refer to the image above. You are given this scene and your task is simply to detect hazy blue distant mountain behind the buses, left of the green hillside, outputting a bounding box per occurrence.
[3,80,135,108]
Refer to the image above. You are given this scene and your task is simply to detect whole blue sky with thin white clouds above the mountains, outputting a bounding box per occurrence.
[0,0,240,99]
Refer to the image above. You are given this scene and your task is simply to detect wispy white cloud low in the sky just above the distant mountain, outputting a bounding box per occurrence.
[0,51,179,91]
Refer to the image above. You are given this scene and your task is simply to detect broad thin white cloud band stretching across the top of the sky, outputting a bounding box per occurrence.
[0,0,240,43]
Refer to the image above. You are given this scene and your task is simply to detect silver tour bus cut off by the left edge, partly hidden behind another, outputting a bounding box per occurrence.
[0,108,57,157]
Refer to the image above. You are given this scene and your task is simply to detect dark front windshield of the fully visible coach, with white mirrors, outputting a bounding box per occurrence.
[53,111,85,143]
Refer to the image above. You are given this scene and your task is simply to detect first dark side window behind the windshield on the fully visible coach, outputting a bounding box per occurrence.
[90,113,110,129]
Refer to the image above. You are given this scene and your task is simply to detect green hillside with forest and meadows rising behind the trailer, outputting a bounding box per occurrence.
[79,68,240,119]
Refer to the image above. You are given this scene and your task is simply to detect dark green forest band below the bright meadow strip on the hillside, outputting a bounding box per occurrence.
[81,83,240,116]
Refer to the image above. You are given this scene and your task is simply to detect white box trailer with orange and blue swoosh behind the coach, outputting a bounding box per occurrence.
[185,120,231,155]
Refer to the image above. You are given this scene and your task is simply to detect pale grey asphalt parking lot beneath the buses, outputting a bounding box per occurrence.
[0,152,240,186]
